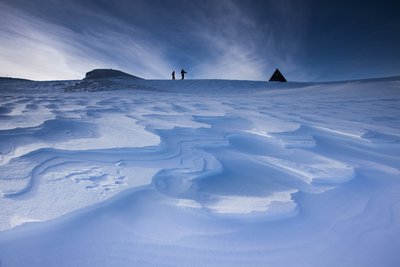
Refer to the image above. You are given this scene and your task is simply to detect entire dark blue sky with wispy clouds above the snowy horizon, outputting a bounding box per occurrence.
[0,0,400,81]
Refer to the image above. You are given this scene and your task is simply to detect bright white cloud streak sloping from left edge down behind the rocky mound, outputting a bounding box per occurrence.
[0,4,170,80]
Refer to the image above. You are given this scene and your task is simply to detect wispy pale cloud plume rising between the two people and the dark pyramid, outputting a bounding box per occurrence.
[188,1,266,79]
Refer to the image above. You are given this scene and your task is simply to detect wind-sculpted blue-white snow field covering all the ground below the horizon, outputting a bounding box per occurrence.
[0,79,400,266]
